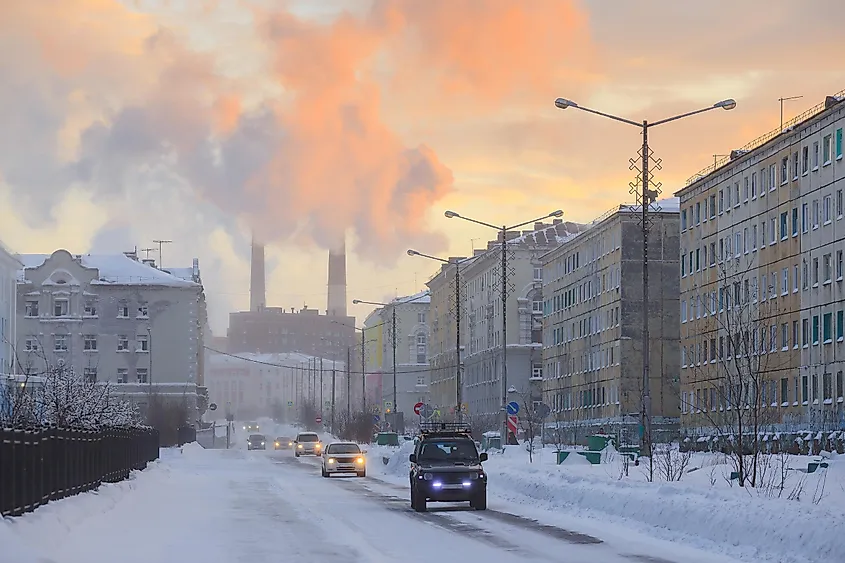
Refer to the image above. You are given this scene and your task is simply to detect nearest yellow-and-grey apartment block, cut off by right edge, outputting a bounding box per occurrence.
[677,95,845,434]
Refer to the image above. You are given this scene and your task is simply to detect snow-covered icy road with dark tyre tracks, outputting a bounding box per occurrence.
[0,445,744,563]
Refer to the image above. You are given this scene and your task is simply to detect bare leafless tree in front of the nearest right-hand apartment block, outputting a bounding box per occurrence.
[681,257,797,487]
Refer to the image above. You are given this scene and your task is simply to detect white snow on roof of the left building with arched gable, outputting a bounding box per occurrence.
[17,254,198,287]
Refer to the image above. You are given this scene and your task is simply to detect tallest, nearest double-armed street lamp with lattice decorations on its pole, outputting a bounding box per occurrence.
[555,94,736,462]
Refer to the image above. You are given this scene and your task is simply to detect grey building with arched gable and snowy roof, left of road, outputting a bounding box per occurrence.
[16,250,203,418]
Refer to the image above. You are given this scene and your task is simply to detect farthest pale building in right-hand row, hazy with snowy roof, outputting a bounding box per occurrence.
[364,291,431,421]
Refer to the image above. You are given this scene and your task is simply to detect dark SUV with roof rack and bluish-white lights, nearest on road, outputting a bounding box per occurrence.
[409,424,487,512]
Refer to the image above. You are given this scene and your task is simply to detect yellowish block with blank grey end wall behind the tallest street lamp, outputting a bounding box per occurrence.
[542,206,680,439]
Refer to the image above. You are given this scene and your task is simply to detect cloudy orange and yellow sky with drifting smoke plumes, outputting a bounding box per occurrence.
[0,0,845,334]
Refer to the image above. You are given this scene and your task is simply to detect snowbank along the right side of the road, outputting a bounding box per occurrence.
[373,444,845,563]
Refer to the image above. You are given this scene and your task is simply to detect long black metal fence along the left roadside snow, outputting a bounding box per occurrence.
[0,427,159,516]
